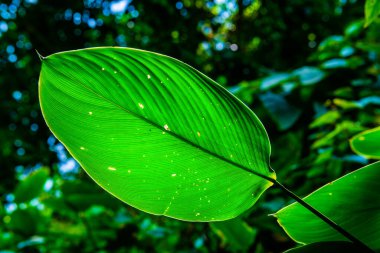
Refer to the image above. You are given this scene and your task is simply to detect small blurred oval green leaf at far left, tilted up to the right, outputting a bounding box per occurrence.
[14,168,49,203]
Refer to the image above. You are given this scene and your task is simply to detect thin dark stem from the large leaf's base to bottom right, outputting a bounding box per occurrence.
[271,179,374,253]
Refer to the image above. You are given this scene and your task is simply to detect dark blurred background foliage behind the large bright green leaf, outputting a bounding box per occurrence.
[0,0,380,253]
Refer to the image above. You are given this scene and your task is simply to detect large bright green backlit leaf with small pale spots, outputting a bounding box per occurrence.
[39,47,275,221]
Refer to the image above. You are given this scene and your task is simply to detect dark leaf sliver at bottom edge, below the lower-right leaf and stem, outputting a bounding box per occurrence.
[285,241,361,253]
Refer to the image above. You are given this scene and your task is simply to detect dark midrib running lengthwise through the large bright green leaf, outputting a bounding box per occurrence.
[42,56,276,184]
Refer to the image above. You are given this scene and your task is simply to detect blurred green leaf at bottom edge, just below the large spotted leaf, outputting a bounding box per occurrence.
[210,217,257,252]
